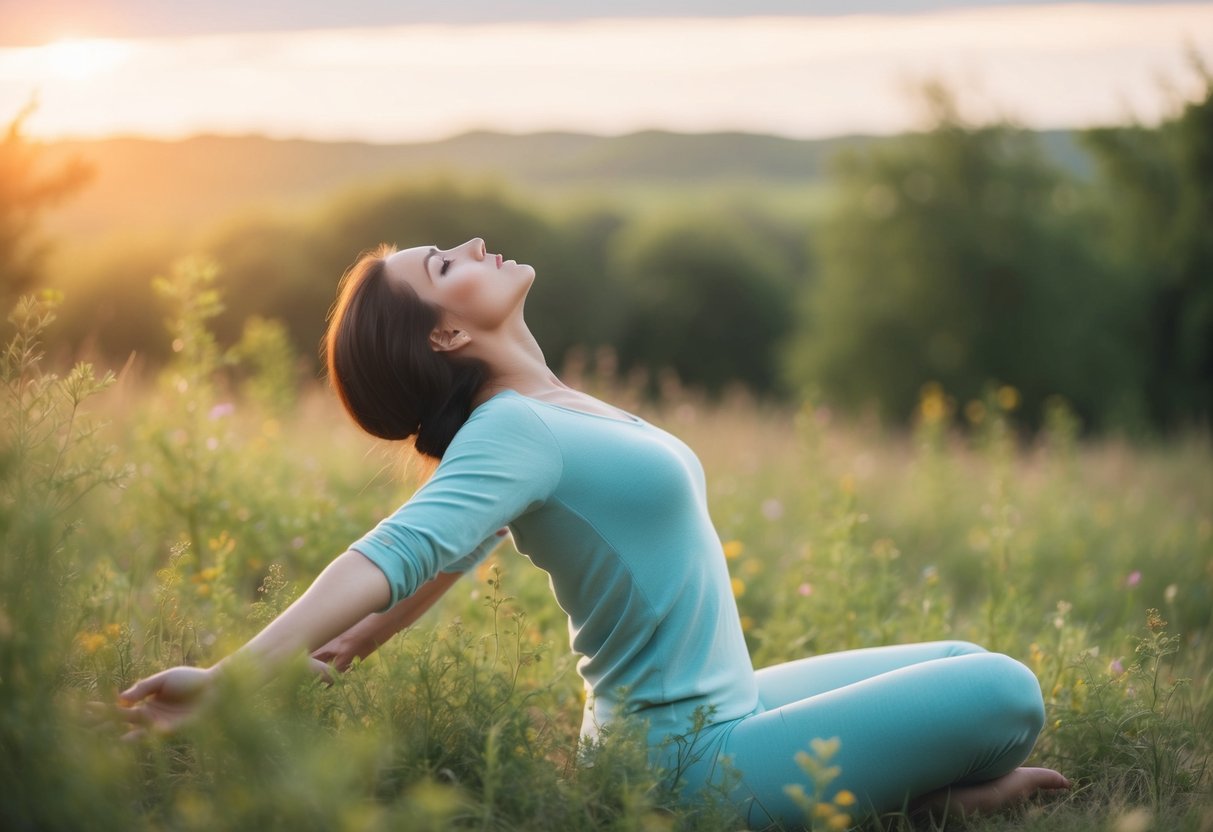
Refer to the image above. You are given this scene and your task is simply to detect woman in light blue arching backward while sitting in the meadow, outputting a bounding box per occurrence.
[123,239,1069,827]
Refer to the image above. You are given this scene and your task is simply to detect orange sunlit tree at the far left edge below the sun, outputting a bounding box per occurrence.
[0,102,92,306]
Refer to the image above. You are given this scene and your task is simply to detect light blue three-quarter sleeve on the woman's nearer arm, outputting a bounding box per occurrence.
[349,395,563,608]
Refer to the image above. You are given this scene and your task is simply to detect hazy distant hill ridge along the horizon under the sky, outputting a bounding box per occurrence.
[45,131,1088,237]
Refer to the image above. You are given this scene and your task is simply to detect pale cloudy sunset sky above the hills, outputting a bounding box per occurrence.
[0,0,1213,142]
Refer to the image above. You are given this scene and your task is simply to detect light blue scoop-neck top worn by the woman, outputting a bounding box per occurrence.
[351,391,758,736]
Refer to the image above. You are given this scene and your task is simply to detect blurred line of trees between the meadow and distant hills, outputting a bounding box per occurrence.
[0,70,1213,432]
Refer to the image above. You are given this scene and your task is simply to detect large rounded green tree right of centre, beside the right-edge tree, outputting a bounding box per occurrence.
[787,85,1139,429]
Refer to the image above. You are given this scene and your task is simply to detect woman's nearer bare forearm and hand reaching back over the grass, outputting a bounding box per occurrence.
[119,551,391,730]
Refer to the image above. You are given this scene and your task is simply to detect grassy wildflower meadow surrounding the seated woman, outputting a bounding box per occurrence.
[0,276,1213,832]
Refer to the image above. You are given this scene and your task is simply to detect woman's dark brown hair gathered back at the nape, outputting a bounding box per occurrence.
[324,244,488,460]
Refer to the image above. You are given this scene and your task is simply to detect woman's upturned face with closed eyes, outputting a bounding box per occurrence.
[386,237,535,338]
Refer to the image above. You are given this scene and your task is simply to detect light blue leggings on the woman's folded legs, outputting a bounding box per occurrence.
[659,642,1044,828]
